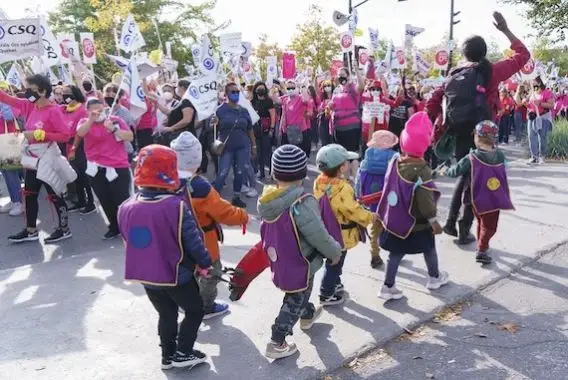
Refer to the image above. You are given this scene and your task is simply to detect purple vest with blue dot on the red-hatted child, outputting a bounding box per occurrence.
[118,195,183,286]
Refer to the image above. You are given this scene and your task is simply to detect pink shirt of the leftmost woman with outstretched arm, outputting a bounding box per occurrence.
[0,91,70,144]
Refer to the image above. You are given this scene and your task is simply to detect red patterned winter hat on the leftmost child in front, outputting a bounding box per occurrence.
[134,144,180,190]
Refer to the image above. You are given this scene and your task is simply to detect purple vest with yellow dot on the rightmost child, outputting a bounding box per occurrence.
[469,154,515,215]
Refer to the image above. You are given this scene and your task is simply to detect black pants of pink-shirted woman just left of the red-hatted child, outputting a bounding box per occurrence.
[91,168,130,232]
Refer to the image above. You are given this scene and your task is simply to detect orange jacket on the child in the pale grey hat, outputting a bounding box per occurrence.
[182,176,248,261]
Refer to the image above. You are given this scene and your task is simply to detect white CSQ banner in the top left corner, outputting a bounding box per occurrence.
[0,18,43,63]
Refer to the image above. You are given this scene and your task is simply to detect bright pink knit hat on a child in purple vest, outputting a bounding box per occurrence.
[400,112,434,157]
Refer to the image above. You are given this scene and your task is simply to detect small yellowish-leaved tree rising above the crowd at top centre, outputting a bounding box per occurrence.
[289,5,341,70]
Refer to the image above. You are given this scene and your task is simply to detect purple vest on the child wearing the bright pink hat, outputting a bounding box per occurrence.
[377,159,440,239]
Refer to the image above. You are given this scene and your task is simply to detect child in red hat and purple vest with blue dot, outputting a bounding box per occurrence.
[118,145,211,369]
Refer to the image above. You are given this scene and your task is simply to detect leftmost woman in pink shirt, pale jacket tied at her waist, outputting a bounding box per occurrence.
[0,74,71,243]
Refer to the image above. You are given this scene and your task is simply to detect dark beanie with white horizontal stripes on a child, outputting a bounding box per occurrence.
[272,144,308,182]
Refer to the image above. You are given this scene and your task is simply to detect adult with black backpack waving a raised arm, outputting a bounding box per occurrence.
[426,12,530,244]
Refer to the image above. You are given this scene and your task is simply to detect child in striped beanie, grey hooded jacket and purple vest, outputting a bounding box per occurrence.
[258,145,341,359]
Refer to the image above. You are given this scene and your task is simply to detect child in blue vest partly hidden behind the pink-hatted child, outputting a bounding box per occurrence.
[355,130,398,268]
